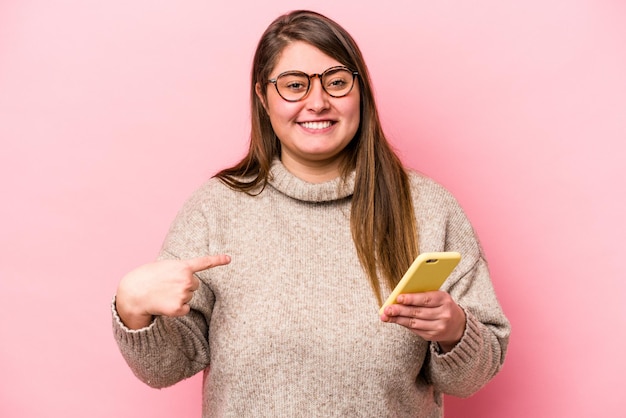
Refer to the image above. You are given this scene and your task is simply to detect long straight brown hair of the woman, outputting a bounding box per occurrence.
[216,10,418,304]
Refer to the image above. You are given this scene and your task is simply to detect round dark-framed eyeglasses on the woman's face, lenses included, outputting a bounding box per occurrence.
[268,66,359,102]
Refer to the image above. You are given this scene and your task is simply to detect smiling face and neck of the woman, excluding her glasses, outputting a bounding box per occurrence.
[256,41,360,183]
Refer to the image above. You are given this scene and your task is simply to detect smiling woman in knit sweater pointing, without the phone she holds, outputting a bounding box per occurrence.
[113,11,509,417]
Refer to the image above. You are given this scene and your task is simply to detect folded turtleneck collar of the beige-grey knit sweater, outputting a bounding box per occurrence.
[269,159,354,202]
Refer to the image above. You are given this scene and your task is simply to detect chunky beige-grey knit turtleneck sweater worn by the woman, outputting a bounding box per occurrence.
[113,158,509,418]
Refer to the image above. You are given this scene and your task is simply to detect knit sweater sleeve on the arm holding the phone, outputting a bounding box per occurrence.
[412,176,510,397]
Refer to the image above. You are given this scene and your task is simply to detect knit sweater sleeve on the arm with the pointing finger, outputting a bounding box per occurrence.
[112,185,215,388]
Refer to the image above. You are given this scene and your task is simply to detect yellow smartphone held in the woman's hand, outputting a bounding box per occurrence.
[378,251,461,315]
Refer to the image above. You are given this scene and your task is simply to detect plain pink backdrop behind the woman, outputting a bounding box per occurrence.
[0,0,626,418]
